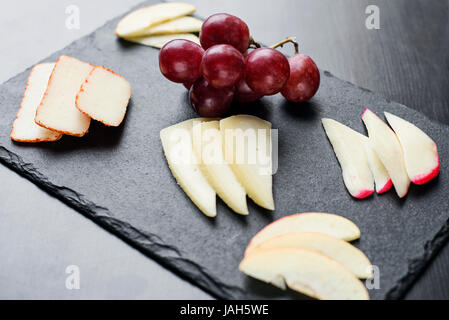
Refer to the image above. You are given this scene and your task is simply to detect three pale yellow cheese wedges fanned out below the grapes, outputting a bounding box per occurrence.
[160,115,274,217]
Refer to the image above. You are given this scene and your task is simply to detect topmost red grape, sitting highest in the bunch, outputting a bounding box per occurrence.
[200,13,249,53]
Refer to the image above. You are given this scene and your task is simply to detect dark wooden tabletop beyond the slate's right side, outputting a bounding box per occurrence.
[185,0,449,299]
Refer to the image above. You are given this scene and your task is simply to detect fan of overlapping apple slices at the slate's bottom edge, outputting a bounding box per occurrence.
[239,213,373,300]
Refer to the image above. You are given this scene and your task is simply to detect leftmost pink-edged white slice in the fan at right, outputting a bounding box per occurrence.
[321,118,374,199]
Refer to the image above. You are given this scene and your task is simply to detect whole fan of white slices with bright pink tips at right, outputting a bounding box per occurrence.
[322,109,440,199]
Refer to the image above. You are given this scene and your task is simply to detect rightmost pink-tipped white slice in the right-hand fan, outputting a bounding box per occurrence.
[385,112,440,184]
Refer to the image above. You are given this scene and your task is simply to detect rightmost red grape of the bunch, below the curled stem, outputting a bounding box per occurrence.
[281,54,320,102]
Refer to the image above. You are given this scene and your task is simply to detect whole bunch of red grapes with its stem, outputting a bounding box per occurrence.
[159,13,320,117]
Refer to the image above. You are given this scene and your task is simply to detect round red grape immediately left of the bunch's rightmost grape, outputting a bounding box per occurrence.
[245,48,290,96]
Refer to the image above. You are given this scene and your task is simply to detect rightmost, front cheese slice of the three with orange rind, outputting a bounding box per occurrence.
[76,66,131,127]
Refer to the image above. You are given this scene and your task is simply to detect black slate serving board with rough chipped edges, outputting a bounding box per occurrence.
[0,1,449,299]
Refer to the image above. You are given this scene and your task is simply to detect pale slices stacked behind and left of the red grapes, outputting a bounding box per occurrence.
[115,2,203,48]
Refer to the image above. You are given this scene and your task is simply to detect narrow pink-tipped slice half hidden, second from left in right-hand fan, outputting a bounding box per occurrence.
[362,136,393,194]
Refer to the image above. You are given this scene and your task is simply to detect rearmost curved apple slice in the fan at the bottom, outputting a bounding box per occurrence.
[245,212,360,255]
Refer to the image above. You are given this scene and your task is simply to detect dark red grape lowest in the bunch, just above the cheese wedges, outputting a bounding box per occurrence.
[189,78,234,117]
